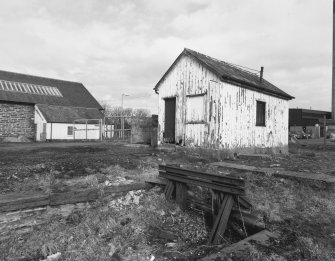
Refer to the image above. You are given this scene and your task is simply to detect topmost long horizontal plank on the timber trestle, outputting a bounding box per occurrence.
[158,165,245,186]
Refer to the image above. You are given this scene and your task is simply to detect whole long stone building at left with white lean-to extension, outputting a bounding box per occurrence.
[0,71,104,141]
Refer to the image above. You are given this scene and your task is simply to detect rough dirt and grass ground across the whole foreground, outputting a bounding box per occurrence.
[0,143,335,260]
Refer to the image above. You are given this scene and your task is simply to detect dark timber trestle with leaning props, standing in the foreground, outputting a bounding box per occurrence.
[159,165,264,244]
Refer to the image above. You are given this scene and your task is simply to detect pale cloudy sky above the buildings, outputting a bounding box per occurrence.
[0,0,332,113]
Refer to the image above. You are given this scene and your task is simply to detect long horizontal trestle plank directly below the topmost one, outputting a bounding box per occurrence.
[159,173,245,195]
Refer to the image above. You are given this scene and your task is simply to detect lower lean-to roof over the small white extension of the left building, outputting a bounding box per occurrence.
[36,104,104,123]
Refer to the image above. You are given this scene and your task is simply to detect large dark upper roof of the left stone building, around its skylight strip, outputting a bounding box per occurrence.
[0,70,102,109]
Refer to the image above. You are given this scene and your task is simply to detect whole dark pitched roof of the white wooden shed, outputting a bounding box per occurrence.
[154,48,294,100]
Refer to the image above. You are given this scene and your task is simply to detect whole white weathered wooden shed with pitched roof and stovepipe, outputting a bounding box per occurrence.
[154,49,293,153]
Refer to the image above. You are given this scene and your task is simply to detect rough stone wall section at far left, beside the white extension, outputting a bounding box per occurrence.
[0,102,35,140]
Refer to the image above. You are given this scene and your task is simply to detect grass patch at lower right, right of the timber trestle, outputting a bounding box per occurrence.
[247,176,335,261]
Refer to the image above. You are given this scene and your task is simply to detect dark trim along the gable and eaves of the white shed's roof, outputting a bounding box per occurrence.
[154,48,295,100]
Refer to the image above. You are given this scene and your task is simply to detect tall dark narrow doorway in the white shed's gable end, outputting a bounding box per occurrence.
[163,98,176,143]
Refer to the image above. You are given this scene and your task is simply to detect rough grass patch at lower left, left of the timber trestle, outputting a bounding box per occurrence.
[0,188,213,260]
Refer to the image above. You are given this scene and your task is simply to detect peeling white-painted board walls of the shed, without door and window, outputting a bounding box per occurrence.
[159,55,288,150]
